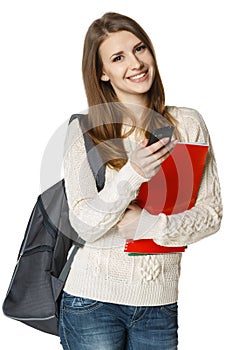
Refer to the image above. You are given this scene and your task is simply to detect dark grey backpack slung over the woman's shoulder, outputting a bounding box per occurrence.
[3,114,105,335]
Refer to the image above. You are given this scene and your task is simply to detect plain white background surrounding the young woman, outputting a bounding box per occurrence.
[0,0,233,350]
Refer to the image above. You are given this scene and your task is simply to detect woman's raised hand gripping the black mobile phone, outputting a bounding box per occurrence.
[130,137,177,179]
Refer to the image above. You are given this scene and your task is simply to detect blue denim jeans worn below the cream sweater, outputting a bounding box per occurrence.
[59,292,178,350]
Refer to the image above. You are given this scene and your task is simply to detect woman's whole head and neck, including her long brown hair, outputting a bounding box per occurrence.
[82,13,178,169]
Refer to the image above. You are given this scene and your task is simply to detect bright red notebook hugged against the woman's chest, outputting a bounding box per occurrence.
[124,143,208,254]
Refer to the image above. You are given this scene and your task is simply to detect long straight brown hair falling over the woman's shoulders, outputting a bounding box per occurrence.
[82,12,175,169]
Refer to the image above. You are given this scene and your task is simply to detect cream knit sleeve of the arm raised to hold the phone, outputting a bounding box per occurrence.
[63,119,146,242]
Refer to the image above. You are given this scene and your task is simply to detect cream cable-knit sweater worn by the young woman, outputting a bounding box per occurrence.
[64,107,222,306]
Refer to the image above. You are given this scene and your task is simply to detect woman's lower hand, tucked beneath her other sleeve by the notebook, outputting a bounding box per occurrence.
[117,203,142,239]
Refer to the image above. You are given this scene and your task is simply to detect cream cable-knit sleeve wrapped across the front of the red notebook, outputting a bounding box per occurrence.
[134,110,222,246]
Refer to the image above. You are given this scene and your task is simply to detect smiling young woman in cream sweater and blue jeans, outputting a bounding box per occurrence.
[59,13,222,350]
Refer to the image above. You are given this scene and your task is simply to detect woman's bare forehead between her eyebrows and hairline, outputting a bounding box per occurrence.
[99,30,141,56]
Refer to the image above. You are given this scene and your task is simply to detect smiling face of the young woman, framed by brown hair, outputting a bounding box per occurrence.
[99,31,155,105]
